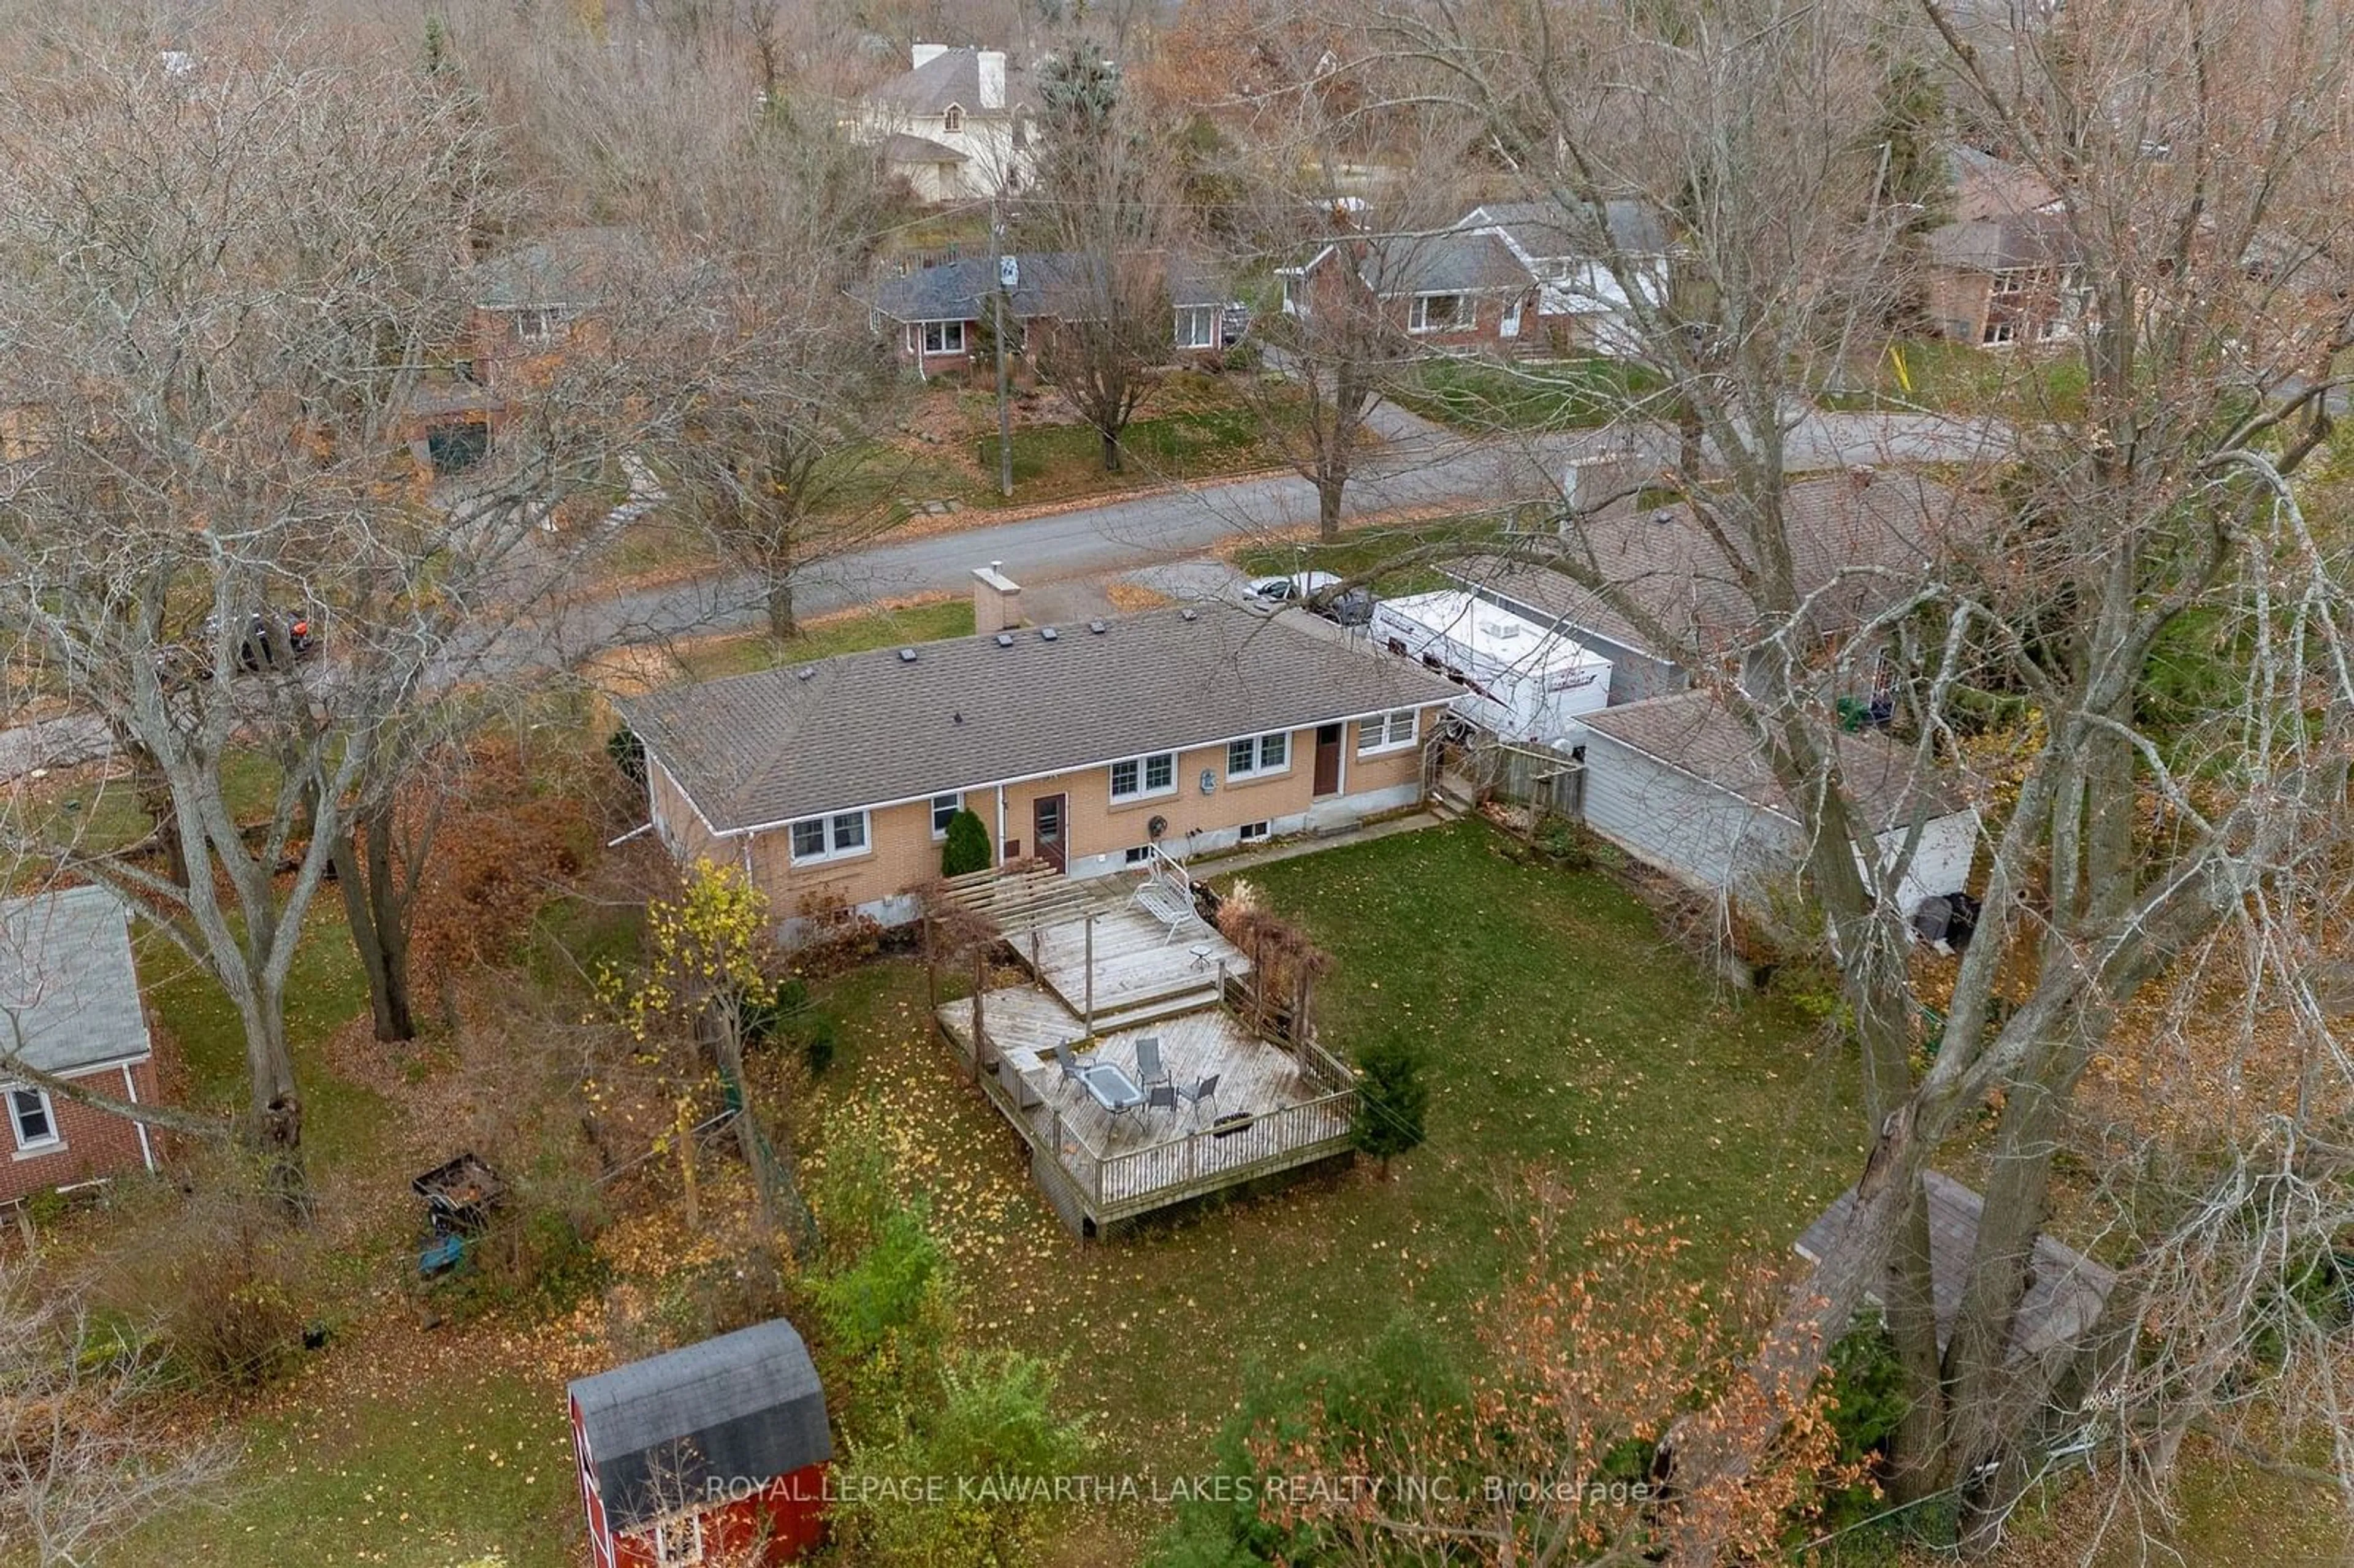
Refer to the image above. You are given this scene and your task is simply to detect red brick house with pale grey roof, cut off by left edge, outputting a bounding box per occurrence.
[0,888,158,1203]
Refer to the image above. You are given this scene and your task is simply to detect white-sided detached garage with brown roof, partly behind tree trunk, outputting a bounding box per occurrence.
[1584,692,1978,916]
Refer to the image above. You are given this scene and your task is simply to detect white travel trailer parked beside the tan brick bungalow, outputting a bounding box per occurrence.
[1370,588,1610,748]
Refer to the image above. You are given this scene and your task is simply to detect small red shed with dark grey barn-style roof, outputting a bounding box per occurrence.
[569,1319,833,1568]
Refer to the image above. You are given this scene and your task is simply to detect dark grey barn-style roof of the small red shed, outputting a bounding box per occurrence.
[569,1319,833,1531]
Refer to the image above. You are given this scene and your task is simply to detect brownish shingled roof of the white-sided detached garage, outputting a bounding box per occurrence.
[1584,690,1964,831]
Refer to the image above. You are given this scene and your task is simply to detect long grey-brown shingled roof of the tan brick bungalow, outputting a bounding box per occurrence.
[622,605,1460,831]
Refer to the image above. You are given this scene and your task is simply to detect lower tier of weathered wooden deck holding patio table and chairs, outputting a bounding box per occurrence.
[939,984,1356,1234]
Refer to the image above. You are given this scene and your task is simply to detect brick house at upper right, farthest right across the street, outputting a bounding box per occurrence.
[1923,146,2079,348]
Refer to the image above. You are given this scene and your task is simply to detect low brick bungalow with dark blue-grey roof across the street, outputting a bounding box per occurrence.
[861,249,1228,377]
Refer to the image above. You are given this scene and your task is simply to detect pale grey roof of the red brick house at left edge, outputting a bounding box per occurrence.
[0,888,151,1078]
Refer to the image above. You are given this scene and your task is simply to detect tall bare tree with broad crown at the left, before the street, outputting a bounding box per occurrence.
[0,19,636,1198]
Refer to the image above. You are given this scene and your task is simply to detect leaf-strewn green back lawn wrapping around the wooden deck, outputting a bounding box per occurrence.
[805,821,1862,1561]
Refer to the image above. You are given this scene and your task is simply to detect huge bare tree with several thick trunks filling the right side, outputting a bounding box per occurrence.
[1262,0,2354,1561]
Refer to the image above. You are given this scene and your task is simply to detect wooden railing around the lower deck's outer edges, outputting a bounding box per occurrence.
[951,1003,1356,1224]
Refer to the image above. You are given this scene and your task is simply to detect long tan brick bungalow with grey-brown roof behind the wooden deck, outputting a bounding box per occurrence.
[622,586,1457,923]
